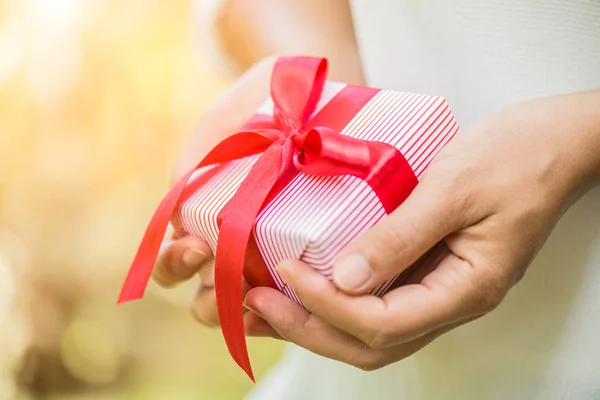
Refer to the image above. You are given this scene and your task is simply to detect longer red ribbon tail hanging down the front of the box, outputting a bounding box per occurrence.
[215,141,291,380]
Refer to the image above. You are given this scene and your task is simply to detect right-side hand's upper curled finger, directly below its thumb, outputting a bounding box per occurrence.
[278,255,488,349]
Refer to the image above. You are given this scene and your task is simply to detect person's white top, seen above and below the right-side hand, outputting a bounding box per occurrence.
[248,0,600,400]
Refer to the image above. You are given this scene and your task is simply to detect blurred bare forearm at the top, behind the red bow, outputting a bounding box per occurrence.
[217,0,364,84]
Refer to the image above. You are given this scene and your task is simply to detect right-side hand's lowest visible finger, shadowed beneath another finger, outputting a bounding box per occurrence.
[246,288,453,370]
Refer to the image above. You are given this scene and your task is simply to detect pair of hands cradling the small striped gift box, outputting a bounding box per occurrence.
[154,60,600,370]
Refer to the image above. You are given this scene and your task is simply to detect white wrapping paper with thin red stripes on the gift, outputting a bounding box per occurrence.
[172,82,459,304]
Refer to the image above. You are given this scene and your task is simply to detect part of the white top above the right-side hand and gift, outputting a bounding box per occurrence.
[352,0,600,127]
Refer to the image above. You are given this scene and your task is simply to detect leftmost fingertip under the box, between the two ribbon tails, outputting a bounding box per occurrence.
[152,236,212,287]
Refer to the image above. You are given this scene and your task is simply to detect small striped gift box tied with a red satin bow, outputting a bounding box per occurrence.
[120,57,459,377]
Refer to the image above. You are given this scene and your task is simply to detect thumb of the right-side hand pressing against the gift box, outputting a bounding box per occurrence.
[333,179,465,294]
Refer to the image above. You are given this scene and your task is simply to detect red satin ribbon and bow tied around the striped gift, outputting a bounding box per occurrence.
[119,57,417,379]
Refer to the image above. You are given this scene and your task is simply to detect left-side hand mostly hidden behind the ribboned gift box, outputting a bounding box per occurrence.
[153,58,274,336]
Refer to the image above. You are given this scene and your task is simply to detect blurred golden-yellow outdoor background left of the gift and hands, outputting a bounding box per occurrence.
[0,0,281,400]
